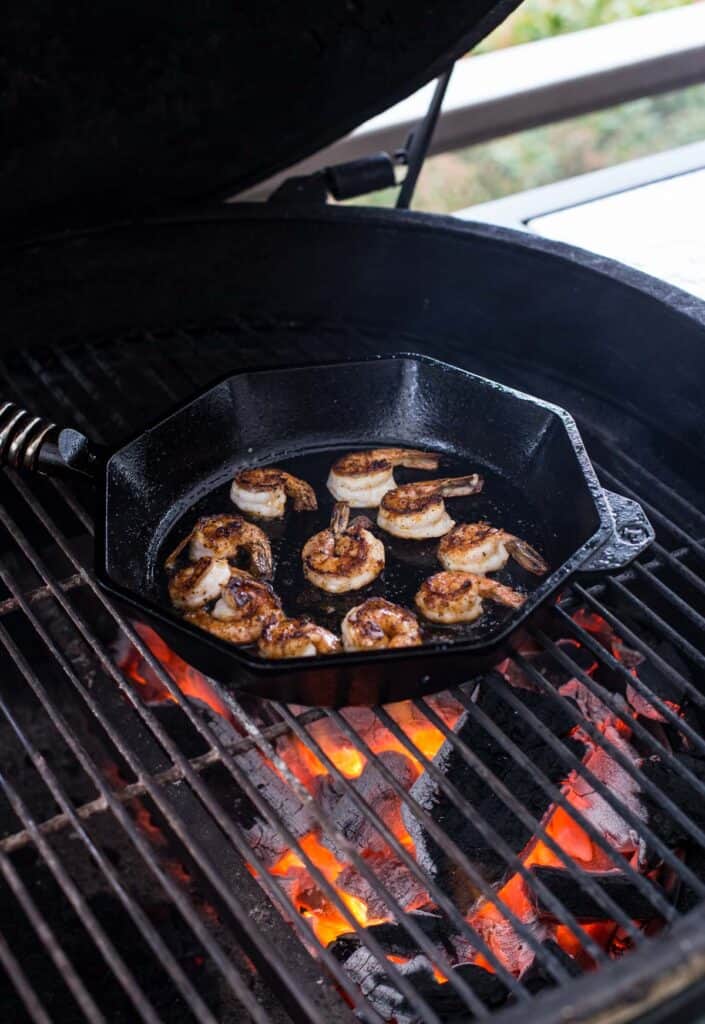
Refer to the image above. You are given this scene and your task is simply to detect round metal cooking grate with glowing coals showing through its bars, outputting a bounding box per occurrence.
[0,331,705,1024]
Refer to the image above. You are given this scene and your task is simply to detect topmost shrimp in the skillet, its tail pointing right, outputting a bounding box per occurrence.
[328,449,439,508]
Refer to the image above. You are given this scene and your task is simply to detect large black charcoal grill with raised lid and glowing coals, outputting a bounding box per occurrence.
[0,3,705,1024]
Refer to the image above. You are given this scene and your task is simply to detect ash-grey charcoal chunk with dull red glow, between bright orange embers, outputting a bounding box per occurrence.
[317,751,416,859]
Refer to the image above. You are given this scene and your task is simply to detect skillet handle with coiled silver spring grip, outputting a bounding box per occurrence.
[0,401,106,479]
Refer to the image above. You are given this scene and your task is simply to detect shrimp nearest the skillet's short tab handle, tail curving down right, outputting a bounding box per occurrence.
[439,522,548,575]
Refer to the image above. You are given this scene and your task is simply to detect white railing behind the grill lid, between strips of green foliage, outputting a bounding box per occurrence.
[237,0,705,199]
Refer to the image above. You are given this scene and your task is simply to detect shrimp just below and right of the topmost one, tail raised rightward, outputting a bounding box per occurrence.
[377,473,484,541]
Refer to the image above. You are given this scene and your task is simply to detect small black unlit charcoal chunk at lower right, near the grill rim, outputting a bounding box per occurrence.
[532,867,656,921]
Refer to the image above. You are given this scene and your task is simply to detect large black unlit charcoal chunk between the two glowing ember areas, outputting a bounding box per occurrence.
[403,674,584,911]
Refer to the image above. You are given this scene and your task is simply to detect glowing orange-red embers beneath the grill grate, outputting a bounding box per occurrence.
[121,609,678,983]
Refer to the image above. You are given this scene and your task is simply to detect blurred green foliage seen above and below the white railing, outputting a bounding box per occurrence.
[344,0,705,213]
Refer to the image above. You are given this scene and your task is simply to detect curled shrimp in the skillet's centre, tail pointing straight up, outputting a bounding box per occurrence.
[301,502,384,594]
